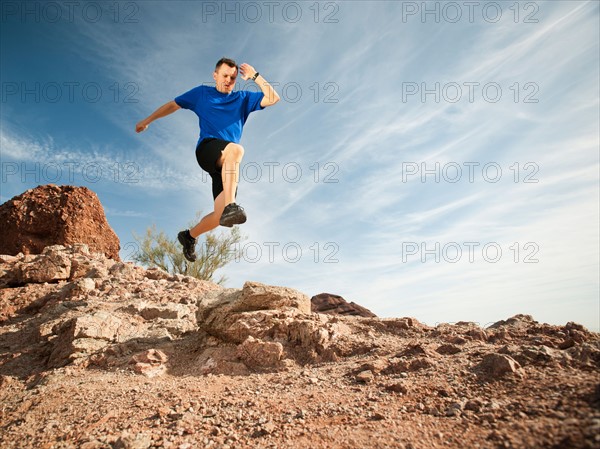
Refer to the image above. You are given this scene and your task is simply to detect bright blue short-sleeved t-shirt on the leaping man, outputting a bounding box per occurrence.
[175,86,264,143]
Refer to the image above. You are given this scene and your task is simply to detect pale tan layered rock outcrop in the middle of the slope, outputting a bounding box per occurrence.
[196,282,352,372]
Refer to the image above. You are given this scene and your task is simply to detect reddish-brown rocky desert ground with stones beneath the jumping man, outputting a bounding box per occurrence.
[0,245,600,449]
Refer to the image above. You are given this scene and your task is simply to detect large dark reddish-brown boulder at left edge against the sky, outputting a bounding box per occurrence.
[0,184,120,260]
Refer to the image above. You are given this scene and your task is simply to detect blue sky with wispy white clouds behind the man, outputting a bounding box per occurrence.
[0,1,600,331]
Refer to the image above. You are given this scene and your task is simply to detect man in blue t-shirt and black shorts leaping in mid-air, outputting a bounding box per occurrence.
[135,58,279,262]
